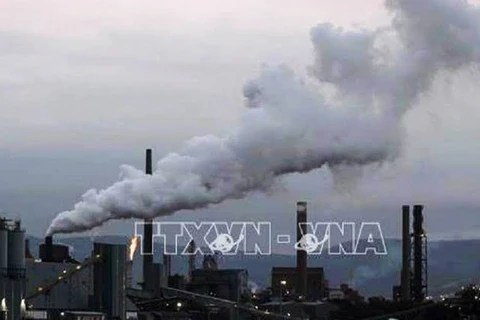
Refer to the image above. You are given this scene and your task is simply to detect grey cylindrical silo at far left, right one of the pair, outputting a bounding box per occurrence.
[7,229,25,278]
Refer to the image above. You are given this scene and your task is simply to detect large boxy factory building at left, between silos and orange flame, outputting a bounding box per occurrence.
[21,237,141,320]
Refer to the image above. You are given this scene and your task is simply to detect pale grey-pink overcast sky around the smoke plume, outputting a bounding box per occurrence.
[0,0,480,239]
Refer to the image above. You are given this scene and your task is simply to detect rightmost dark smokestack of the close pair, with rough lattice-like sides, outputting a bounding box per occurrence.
[411,205,427,302]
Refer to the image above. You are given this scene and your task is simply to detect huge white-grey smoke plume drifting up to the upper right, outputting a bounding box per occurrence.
[47,0,480,235]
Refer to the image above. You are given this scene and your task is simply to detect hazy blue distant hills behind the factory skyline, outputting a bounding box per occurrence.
[29,236,480,297]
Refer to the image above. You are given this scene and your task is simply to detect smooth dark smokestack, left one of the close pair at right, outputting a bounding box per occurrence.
[400,206,411,301]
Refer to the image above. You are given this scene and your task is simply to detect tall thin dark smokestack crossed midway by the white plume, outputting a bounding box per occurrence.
[143,149,154,290]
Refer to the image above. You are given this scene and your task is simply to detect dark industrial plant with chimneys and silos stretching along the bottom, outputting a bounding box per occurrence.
[0,150,478,320]
